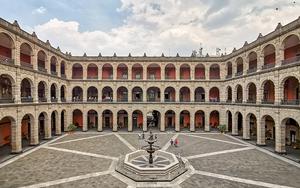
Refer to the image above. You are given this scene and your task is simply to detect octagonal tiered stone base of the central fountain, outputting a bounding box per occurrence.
[116,150,187,182]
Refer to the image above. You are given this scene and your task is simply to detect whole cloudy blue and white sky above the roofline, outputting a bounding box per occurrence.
[0,0,300,56]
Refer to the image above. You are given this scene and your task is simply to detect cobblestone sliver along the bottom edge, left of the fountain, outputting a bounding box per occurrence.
[49,175,127,188]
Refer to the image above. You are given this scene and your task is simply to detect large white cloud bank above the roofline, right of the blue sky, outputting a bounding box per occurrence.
[34,0,300,56]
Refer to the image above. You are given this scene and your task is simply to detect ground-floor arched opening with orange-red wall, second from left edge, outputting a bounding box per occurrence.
[21,114,34,150]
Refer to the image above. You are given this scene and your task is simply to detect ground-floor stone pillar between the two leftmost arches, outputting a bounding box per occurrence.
[11,118,22,153]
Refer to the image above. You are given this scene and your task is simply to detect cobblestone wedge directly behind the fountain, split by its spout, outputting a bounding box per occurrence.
[120,134,174,149]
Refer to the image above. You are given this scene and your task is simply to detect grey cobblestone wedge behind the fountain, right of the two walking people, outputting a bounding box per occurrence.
[167,135,244,156]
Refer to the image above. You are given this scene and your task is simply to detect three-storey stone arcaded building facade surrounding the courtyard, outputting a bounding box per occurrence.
[0,18,300,156]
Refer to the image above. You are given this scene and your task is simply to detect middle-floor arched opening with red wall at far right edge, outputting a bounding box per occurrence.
[282,77,300,105]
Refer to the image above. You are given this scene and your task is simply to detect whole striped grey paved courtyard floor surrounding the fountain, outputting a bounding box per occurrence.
[0,132,300,188]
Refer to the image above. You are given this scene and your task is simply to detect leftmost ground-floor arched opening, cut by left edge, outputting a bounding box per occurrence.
[0,117,16,157]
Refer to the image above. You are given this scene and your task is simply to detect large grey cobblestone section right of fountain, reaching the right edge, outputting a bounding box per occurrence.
[190,150,300,187]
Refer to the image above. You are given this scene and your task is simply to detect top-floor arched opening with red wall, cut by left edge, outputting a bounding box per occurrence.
[0,33,14,63]
